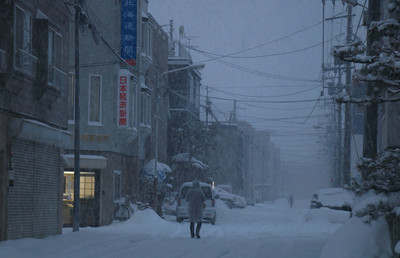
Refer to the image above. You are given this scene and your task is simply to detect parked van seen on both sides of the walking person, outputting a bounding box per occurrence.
[176,182,217,225]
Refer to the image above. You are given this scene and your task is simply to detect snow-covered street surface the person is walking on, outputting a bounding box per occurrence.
[0,199,347,258]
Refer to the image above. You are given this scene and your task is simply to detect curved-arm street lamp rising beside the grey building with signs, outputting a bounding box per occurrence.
[154,63,205,212]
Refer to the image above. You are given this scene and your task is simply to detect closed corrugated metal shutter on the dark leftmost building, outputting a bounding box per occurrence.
[8,140,61,239]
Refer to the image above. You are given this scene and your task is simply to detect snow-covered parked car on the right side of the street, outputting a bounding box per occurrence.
[311,188,355,212]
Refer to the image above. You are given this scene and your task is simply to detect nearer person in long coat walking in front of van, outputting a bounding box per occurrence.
[186,180,206,238]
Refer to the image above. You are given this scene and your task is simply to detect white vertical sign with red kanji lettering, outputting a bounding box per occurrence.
[117,70,130,128]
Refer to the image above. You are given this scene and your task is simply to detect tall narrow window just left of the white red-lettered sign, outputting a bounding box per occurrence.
[89,75,101,124]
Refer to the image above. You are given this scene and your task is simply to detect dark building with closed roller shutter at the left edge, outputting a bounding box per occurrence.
[0,0,69,241]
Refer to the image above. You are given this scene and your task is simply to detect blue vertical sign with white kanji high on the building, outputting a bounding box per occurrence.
[121,0,137,65]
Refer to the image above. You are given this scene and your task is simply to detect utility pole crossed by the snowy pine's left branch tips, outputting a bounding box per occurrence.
[342,5,353,185]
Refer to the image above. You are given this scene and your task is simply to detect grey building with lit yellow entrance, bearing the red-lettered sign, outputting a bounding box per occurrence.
[63,0,168,226]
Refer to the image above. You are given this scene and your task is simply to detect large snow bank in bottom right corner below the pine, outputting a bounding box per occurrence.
[320,217,391,258]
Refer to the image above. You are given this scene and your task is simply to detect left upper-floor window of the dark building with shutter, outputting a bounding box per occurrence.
[14,6,37,76]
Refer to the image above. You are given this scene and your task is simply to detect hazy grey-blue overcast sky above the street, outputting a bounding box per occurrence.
[149,0,366,177]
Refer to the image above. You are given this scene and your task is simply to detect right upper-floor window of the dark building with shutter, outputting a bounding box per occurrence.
[48,29,65,89]
